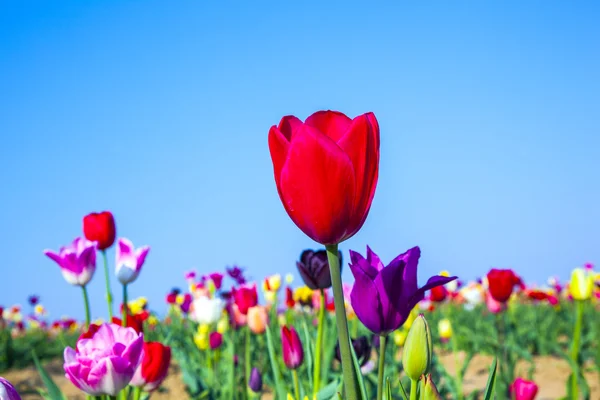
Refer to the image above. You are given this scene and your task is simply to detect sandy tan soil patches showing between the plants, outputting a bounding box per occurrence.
[4,354,600,400]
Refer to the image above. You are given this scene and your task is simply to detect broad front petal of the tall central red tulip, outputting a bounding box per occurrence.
[272,125,355,244]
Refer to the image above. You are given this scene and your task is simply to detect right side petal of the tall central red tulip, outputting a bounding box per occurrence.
[337,113,379,234]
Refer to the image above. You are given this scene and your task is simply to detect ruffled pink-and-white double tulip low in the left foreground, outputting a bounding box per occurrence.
[64,324,144,396]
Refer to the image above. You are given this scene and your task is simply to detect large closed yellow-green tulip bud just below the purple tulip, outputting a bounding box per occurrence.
[402,314,432,381]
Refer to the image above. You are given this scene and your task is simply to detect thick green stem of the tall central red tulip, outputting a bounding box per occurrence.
[325,244,358,400]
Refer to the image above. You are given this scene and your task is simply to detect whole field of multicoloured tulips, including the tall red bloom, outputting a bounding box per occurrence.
[0,111,600,400]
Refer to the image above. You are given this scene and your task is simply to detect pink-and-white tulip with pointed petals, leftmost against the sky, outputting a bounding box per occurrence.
[44,237,97,286]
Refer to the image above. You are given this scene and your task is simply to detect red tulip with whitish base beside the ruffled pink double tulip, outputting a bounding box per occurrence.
[130,342,171,392]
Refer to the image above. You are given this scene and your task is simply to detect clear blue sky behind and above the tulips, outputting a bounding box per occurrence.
[0,0,600,318]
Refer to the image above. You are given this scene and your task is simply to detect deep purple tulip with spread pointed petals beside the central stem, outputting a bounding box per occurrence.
[350,246,456,335]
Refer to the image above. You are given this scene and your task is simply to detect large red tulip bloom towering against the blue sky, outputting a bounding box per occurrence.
[269,111,379,245]
